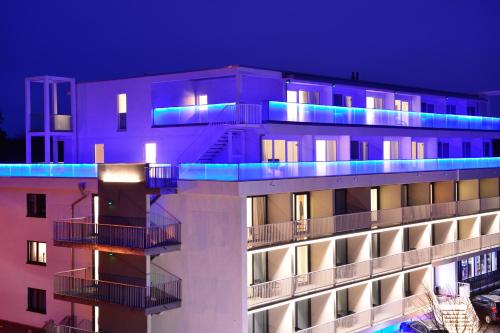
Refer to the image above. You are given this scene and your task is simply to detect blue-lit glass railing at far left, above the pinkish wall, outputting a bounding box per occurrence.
[0,164,97,178]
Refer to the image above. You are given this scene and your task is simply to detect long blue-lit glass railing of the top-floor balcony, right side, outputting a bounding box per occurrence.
[264,101,500,131]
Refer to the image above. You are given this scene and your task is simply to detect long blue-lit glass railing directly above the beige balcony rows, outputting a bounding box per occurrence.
[179,157,500,181]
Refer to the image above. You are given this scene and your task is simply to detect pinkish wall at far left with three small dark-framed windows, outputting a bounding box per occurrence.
[0,177,97,327]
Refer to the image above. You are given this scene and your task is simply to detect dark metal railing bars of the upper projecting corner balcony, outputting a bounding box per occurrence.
[54,217,181,250]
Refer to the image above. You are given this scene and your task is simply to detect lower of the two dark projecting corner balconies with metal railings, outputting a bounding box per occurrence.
[54,268,182,314]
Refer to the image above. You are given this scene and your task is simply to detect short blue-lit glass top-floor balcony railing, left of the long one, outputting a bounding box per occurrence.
[153,103,262,127]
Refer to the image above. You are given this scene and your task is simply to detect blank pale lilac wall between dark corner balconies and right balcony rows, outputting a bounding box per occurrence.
[151,182,247,333]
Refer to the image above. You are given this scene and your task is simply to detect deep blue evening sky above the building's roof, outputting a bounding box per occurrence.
[0,0,500,135]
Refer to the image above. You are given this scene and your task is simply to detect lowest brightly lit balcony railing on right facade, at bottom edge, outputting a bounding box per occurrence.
[298,294,430,333]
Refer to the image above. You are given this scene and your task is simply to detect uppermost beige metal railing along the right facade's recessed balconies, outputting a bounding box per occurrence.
[247,197,500,249]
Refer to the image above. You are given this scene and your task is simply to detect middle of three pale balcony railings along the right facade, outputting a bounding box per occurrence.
[248,233,500,311]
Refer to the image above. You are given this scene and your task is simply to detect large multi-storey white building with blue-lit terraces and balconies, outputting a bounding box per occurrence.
[0,66,500,333]
